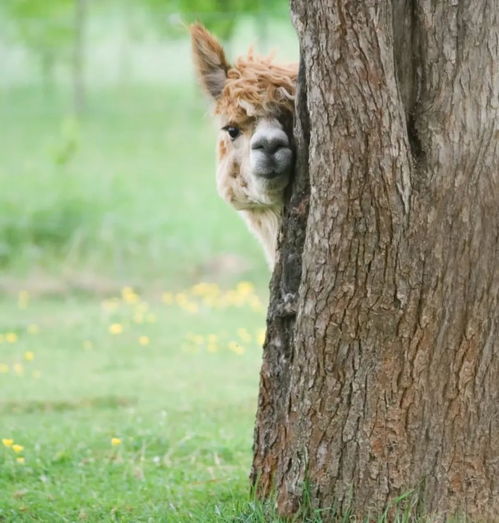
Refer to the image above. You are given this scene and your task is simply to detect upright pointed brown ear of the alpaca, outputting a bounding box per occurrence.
[189,24,230,99]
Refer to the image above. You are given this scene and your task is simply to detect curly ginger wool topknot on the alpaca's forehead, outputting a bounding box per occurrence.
[215,51,298,121]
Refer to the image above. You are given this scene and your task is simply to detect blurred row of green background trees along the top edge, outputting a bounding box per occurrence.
[0,0,288,113]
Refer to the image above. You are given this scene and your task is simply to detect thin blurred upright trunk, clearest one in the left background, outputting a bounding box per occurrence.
[73,0,87,114]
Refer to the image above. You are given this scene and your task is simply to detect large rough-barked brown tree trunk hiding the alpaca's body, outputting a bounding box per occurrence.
[252,0,499,521]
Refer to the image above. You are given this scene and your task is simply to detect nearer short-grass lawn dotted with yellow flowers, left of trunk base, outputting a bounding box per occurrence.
[0,283,270,521]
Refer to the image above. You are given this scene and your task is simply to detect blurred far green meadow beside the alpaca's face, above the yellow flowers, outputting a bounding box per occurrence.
[0,81,268,281]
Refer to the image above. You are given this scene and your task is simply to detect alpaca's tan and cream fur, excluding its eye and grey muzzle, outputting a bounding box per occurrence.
[190,24,298,266]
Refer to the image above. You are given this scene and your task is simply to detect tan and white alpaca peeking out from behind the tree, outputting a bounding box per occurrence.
[190,24,298,269]
